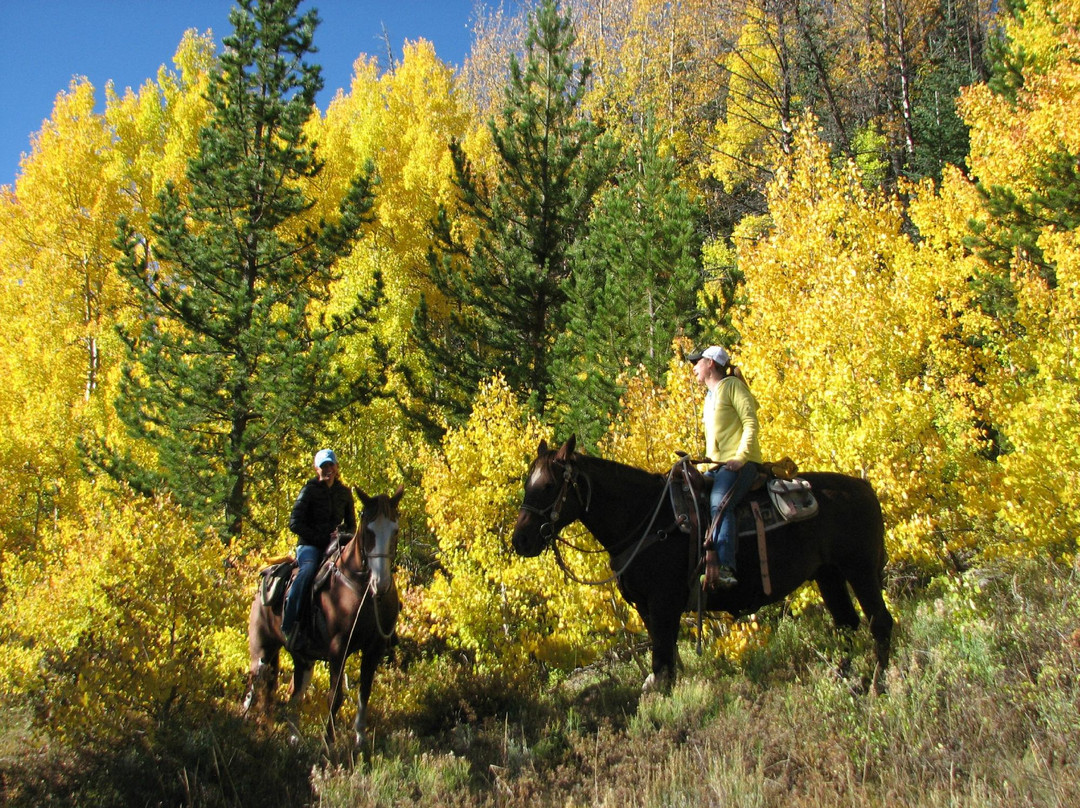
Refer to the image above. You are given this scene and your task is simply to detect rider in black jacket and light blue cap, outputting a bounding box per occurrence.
[281,449,356,651]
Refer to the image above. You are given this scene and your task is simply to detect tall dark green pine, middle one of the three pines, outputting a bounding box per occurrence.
[414,0,616,416]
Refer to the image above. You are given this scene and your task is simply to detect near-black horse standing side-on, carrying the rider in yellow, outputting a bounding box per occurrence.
[513,437,893,689]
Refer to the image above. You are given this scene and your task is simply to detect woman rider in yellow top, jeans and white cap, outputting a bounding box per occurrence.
[687,345,761,589]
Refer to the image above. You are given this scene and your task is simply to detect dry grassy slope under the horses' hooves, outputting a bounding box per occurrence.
[0,563,1080,808]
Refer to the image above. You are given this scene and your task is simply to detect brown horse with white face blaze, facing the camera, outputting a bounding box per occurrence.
[244,486,404,743]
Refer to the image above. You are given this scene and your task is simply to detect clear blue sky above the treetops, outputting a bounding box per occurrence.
[0,0,486,185]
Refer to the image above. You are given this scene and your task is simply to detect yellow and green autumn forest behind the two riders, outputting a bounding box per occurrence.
[0,0,1080,803]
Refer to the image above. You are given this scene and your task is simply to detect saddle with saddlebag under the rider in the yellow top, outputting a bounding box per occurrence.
[670,453,818,595]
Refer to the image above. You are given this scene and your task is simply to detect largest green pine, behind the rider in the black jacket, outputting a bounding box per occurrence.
[107,0,378,539]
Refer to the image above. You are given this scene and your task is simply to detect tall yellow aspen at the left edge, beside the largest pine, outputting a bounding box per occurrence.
[0,81,126,550]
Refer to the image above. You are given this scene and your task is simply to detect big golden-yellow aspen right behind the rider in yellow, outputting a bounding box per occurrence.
[734,120,978,565]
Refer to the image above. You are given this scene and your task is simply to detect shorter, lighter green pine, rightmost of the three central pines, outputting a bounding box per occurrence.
[555,121,703,445]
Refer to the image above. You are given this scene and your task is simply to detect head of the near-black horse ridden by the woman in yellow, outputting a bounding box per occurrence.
[511,435,582,557]
